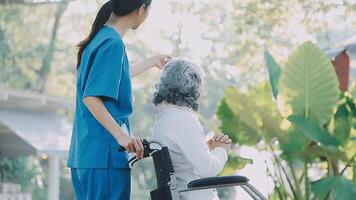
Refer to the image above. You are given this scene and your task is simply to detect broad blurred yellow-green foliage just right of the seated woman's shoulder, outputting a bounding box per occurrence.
[218,85,283,143]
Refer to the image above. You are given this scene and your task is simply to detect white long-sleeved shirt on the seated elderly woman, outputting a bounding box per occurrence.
[152,104,227,200]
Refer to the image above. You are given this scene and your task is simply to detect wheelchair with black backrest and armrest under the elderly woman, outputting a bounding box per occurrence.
[120,139,267,200]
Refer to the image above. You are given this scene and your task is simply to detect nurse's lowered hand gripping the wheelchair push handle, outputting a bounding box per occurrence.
[118,134,144,159]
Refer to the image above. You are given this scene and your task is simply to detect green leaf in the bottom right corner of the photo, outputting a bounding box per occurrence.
[311,176,356,200]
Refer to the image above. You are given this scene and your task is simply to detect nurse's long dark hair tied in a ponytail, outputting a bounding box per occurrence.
[77,0,152,69]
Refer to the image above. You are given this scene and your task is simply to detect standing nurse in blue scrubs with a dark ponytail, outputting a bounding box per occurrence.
[67,0,170,200]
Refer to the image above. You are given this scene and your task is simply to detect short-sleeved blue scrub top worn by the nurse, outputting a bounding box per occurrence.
[67,26,132,168]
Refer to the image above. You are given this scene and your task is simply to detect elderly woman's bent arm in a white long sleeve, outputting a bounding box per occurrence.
[172,113,227,177]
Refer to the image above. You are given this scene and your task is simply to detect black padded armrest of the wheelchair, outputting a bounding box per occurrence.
[188,176,249,190]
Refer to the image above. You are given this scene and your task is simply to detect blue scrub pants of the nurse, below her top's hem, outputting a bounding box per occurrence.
[71,167,131,200]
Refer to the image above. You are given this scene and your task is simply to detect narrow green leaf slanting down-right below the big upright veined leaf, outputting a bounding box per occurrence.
[288,115,340,147]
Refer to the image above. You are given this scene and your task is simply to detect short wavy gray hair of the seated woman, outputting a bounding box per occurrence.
[153,58,204,111]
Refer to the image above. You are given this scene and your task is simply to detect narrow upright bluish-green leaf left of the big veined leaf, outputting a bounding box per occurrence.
[264,49,281,99]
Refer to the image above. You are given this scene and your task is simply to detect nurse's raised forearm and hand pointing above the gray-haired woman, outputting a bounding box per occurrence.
[131,55,171,77]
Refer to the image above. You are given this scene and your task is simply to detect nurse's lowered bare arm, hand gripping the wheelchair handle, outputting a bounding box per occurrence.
[83,96,143,158]
